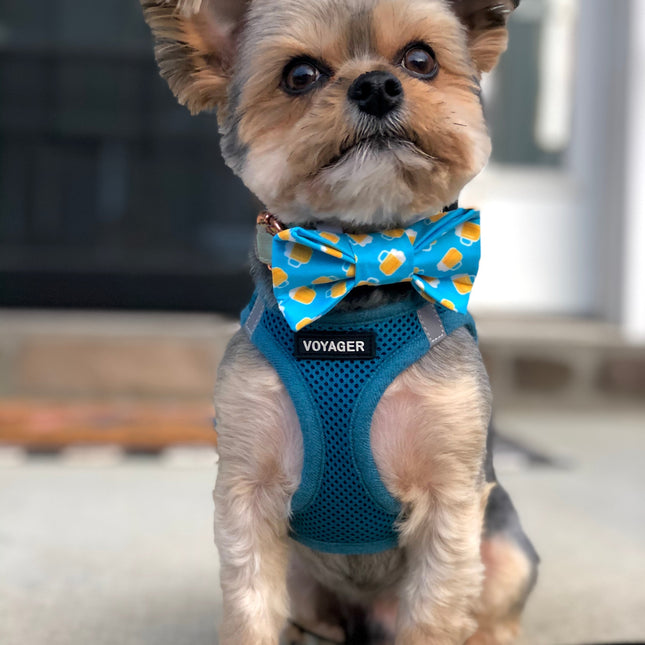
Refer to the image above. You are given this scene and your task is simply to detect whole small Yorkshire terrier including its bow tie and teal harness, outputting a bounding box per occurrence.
[142,0,538,645]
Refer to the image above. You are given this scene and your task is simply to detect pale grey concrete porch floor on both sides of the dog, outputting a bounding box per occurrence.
[0,408,645,645]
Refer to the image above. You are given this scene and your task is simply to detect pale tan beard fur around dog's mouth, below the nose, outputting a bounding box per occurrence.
[236,110,478,232]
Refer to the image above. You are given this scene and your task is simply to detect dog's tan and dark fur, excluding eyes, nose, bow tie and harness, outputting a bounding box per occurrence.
[142,0,537,645]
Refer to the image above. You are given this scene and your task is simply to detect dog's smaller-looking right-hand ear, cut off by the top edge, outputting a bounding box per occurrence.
[449,0,520,73]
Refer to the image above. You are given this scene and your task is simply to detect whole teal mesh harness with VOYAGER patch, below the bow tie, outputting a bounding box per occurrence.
[242,292,476,554]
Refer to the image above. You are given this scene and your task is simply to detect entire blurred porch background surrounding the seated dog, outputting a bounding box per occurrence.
[0,0,645,645]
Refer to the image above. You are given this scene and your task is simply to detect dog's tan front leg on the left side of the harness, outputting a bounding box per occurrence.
[214,334,302,645]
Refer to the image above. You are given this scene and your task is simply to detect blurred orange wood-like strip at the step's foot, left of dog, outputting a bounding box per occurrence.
[0,399,217,449]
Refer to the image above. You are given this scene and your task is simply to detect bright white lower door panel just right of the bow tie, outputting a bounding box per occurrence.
[461,166,593,315]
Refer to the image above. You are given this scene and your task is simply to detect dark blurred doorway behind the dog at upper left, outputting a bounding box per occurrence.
[0,0,257,313]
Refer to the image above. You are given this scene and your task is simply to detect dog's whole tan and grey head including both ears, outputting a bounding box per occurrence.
[143,0,518,228]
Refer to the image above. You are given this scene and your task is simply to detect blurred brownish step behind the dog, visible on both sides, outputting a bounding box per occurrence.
[0,310,645,407]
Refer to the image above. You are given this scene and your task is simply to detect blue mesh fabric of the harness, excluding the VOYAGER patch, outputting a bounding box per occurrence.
[253,298,429,553]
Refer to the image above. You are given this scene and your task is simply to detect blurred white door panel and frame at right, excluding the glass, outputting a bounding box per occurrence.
[462,0,645,337]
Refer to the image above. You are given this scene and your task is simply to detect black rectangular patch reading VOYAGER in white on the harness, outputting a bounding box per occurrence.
[295,331,376,361]
